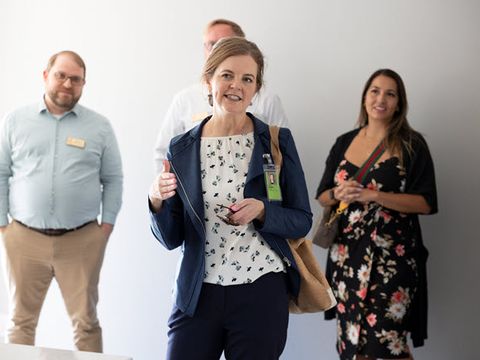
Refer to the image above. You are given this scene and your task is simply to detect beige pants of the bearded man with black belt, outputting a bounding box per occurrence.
[2,221,107,352]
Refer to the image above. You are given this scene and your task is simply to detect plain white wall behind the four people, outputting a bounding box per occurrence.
[0,0,480,360]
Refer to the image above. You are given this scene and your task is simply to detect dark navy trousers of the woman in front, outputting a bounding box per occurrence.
[167,273,288,360]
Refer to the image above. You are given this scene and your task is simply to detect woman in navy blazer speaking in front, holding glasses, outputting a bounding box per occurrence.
[149,38,312,360]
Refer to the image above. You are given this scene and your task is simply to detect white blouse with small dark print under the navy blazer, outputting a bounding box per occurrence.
[200,132,285,286]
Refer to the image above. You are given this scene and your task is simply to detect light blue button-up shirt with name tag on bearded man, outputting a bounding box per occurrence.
[0,101,123,229]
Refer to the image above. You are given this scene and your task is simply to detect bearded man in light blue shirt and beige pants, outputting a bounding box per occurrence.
[0,51,123,352]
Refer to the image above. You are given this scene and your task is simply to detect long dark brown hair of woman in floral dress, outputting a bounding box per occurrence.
[357,69,415,162]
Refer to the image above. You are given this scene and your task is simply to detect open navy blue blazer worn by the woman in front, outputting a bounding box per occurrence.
[150,113,312,316]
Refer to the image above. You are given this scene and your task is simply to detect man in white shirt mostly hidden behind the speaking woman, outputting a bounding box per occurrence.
[154,19,288,174]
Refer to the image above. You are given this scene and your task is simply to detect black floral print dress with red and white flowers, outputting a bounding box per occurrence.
[328,157,418,359]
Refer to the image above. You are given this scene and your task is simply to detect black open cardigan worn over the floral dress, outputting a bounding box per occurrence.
[316,129,438,347]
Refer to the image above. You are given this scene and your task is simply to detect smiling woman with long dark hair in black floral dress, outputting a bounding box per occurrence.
[317,69,437,360]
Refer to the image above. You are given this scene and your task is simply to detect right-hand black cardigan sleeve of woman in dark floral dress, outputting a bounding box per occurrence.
[405,133,438,214]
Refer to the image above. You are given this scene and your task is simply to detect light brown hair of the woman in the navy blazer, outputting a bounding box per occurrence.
[202,36,264,91]
